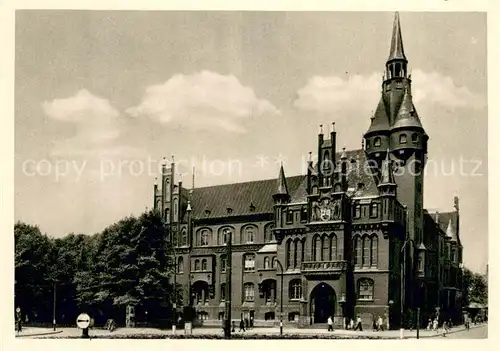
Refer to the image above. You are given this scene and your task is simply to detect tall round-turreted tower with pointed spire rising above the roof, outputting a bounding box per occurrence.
[364,13,429,250]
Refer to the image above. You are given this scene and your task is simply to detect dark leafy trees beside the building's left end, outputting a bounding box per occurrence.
[14,211,179,324]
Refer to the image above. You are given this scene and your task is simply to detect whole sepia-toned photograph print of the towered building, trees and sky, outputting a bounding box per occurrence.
[2,1,495,347]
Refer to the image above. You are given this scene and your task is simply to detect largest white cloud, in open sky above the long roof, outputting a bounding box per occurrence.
[127,71,278,133]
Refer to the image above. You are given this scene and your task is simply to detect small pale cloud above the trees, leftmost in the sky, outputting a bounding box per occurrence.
[42,89,120,156]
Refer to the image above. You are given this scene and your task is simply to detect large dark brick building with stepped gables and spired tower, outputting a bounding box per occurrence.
[154,14,462,329]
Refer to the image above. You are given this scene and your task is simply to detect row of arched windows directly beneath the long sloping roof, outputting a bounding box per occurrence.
[195,223,274,246]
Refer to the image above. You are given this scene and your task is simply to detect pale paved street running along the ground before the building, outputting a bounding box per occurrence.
[16,325,488,339]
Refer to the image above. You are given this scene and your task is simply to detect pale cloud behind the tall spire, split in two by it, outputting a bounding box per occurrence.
[294,69,485,114]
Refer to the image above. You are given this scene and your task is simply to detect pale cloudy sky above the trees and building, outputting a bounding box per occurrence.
[15,10,488,272]
